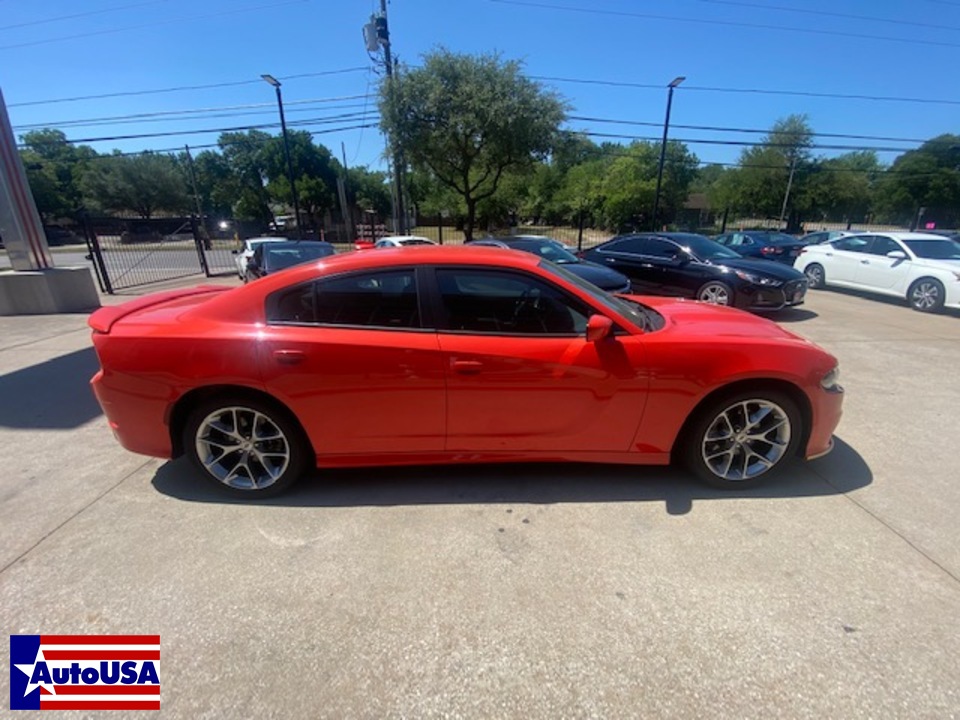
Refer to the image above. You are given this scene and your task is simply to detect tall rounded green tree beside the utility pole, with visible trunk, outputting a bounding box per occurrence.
[380,49,565,245]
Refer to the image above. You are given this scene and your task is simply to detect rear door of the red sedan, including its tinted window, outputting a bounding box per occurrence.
[258,270,446,455]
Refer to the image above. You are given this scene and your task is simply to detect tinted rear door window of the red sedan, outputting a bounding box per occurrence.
[267,270,421,328]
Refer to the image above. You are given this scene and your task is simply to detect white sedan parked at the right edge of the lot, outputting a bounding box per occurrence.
[793,232,960,312]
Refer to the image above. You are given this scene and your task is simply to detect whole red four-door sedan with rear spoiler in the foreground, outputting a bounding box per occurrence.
[90,246,843,497]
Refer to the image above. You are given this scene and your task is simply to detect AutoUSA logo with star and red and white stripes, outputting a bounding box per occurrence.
[10,635,160,710]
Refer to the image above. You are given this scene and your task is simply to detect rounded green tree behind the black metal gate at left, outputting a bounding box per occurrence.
[81,152,191,218]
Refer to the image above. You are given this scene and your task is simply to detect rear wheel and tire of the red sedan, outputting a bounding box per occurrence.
[183,396,310,498]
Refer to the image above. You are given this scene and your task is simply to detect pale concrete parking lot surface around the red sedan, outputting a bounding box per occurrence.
[0,281,960,718]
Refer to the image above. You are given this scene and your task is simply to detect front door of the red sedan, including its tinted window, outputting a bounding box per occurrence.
[437,269,648,452]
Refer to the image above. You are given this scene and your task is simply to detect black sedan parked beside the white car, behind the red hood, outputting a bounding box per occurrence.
[583,233,807,310]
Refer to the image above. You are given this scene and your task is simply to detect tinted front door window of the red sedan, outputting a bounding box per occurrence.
[437,268,589,335]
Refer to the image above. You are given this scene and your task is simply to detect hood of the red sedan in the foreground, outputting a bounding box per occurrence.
[633,295,814,346]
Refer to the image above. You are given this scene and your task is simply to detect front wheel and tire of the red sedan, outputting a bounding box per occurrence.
[675,390,806,489]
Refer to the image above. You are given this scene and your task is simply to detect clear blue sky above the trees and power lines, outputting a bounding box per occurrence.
[0,0,960,167]
